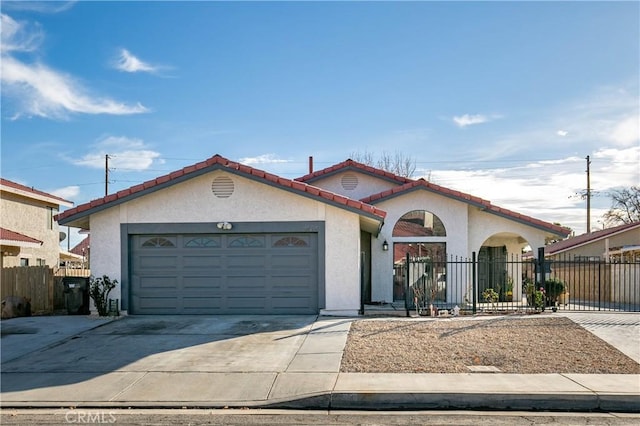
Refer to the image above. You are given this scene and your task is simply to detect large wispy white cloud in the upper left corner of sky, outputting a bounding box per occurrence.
[0,15,148,119]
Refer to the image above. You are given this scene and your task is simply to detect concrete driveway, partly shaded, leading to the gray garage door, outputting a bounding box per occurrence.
[2,316,351,406]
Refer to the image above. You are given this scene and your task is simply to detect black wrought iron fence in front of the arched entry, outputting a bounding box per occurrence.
[396,253,640,315]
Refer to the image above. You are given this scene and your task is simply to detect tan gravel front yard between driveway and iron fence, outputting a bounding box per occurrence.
[341,315,640,374]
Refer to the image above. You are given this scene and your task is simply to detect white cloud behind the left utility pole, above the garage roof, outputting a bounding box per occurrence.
[65,136,162,172]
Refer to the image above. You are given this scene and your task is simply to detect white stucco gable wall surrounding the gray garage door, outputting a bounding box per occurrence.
[91,170,360,313]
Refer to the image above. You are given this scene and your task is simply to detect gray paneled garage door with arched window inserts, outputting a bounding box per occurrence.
[129,233,318,314]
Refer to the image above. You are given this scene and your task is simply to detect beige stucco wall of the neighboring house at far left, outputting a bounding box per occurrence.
[0,192,60,267]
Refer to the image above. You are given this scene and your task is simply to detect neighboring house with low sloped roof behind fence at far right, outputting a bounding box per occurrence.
[544,222,640,262]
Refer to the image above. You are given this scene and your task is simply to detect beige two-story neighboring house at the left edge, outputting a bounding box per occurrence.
[0,178,73,267]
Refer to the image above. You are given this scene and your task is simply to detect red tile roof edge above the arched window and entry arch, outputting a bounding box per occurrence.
[360,179,571,236]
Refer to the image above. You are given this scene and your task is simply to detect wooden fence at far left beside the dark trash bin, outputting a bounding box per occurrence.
[0,266,91,315]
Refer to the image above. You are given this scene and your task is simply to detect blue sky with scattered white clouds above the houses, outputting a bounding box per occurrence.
[1,1,640,248]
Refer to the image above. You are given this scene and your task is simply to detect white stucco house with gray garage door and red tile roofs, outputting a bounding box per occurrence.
[57,155,570,315]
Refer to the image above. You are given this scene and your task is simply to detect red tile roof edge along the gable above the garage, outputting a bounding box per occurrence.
[56,154,387,225]
